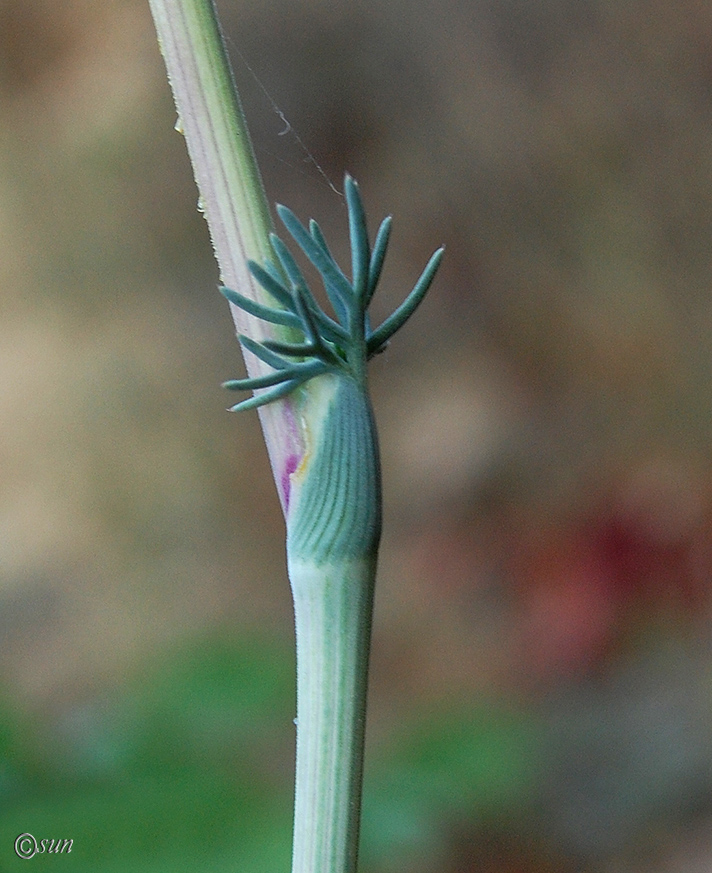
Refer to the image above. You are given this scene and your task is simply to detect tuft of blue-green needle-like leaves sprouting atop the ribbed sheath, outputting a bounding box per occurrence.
[220,175,443,412]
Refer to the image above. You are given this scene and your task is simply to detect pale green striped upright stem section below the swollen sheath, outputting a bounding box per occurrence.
[289,560,375,873]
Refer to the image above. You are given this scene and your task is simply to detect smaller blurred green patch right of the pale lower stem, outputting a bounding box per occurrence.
[363,701,542,870]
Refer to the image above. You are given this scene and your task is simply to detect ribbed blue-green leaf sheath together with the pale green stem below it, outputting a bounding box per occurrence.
[287,375,381,873]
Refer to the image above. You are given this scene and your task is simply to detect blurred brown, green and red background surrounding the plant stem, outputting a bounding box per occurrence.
[0,0,712,873]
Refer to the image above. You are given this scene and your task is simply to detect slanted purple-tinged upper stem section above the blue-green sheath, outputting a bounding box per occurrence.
[149,0,304,510]
